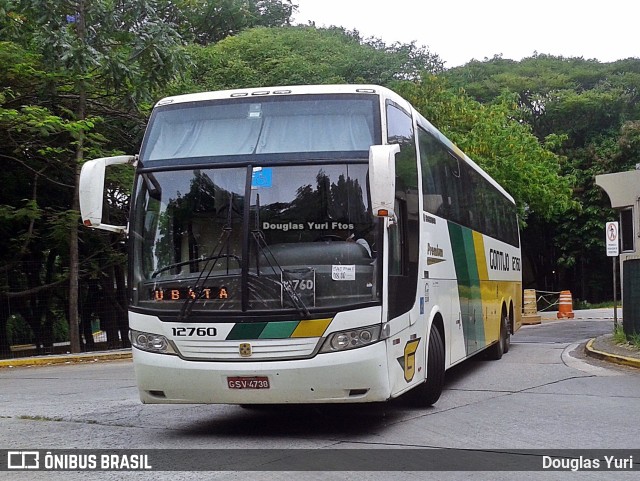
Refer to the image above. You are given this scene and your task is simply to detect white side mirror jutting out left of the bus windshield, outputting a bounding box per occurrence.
[79,155,136,233]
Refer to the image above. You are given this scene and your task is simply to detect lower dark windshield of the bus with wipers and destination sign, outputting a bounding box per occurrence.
[131,164,379,315]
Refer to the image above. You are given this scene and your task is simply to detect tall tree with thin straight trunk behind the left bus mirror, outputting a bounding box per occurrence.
[2,0,184,352]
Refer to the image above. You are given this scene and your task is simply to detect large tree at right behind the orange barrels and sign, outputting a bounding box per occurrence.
[445,55,640,301]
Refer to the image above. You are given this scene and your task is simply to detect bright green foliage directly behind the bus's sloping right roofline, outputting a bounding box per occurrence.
[395,77,571,224]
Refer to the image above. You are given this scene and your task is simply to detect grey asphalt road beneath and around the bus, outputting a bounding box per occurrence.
[0,315,640,481]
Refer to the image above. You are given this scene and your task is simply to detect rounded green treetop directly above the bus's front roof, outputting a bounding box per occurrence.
[168,27,442,93]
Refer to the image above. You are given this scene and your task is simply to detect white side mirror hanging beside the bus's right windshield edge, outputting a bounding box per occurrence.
[369,144,400,219]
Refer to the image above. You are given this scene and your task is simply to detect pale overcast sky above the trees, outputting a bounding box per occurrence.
[293,0,640,68]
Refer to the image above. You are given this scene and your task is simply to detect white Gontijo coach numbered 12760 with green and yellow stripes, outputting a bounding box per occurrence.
[80,85,522,406]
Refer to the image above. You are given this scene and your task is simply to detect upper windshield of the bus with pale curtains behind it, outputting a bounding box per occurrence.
[140,95,377,164]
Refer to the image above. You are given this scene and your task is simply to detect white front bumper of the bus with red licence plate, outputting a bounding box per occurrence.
[133,342,390,404]
